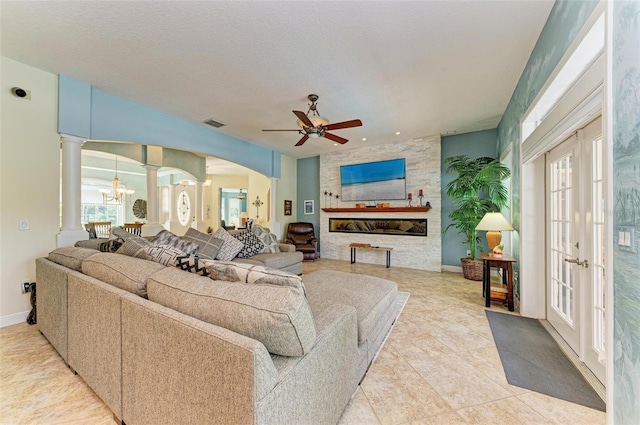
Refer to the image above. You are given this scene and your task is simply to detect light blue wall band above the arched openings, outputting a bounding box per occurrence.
[58,75,280,177]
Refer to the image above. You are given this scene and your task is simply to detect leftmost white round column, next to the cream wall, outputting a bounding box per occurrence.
[57,134,89,247]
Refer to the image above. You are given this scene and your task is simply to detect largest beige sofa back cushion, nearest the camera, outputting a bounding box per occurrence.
[147,268,316,356]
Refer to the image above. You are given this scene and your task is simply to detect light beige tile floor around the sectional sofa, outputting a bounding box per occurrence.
[0,259,605,425]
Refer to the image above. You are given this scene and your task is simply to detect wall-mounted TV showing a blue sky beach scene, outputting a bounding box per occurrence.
[340,158,406,202]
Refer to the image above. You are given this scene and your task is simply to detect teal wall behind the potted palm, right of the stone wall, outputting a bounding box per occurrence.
[440,129,498,266]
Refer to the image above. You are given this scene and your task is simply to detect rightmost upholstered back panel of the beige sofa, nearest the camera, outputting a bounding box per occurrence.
[122,294,278,424]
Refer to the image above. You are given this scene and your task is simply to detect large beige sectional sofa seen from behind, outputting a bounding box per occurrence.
[36,248,409,425]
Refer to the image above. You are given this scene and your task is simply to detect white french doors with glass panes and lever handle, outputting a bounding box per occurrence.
[546,117,607,383]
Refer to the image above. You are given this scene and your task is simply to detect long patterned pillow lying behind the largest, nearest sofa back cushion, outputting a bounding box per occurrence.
[206,261,306,296]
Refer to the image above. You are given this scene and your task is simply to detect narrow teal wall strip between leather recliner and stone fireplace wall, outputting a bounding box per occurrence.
[296,156,322,243]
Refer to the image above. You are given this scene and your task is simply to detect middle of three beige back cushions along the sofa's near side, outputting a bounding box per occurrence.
[82,252,166,298]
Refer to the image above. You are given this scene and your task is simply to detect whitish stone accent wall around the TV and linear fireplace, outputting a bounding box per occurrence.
[320,136,442,271]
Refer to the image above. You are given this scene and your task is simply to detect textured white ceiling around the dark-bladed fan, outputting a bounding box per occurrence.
[0,0,553,158]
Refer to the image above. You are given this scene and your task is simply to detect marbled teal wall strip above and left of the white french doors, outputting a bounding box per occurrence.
[497,0,598,294]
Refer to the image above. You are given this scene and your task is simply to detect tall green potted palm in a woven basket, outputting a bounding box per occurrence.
[442,155,511,280]
